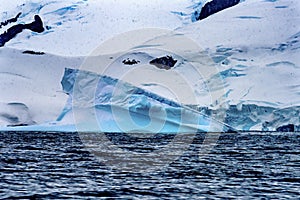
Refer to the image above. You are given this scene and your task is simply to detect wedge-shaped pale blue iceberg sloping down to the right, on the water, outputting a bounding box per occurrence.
[58,68,233,133]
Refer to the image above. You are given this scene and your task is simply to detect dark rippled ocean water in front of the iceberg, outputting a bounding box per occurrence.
[0,132,300,199]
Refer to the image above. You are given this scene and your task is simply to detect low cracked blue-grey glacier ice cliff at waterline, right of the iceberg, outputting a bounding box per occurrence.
[195,104,300,131]
